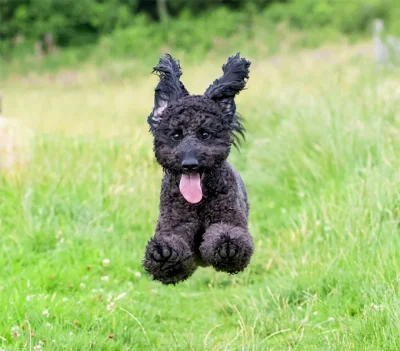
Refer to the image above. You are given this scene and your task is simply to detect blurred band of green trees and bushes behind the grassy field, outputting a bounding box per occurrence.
[0,0,400,70]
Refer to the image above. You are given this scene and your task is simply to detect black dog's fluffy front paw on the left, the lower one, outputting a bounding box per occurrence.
[143,235,196,284]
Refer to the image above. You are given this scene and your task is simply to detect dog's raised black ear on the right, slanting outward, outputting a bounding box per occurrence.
[204,53,251,122]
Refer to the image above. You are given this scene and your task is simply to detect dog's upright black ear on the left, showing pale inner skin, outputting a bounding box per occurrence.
[147,54,189,131]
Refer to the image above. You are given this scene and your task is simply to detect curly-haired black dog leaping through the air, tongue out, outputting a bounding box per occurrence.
[143,54,254,284]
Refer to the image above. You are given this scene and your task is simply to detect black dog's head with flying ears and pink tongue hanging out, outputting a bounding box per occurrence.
[147,54,250,203]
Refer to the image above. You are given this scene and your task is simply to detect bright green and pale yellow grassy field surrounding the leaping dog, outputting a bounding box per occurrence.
[0,45,400,351]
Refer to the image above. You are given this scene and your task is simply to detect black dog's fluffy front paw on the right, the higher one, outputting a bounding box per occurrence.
[200,223,254,274]
